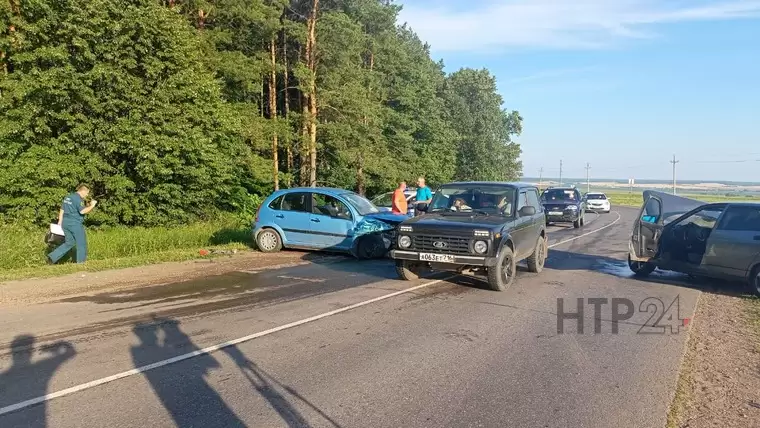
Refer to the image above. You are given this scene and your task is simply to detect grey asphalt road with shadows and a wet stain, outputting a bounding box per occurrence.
[0,208,698,428]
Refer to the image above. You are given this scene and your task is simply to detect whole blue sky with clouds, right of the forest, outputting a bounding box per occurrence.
[398,0,760,182]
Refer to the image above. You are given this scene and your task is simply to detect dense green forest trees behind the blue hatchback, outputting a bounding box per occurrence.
[0,0,522,225]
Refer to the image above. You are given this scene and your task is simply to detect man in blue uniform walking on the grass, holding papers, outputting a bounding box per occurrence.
[48,184,98,264]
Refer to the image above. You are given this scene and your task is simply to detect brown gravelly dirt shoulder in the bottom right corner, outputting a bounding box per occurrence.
[671,292,760,428]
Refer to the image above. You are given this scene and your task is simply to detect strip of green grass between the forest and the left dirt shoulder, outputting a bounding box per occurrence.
[0,219,252,280]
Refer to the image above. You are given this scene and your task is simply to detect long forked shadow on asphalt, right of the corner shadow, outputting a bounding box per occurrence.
[132,318,339,428]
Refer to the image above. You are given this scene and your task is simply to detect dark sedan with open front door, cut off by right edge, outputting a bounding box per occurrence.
[628,190,760,296]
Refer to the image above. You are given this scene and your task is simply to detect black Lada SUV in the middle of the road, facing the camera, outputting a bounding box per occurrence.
[391,182,548,291]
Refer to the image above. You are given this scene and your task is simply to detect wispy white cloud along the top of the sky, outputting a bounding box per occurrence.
[400,0,760,52]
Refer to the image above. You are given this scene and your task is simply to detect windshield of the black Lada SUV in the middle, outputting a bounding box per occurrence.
[428,185,515,216]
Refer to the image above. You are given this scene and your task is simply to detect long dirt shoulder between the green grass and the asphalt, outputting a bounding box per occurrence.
[0,251,345,305]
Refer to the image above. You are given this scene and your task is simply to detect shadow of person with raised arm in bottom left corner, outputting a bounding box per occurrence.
[0,335,76,428]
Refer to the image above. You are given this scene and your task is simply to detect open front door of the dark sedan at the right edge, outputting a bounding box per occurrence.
[629,190,705,262]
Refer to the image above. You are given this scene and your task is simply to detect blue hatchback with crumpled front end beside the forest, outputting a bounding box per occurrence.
[253,187,409,258]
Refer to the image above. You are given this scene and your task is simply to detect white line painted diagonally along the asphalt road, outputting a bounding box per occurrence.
[0,212,620,416]
